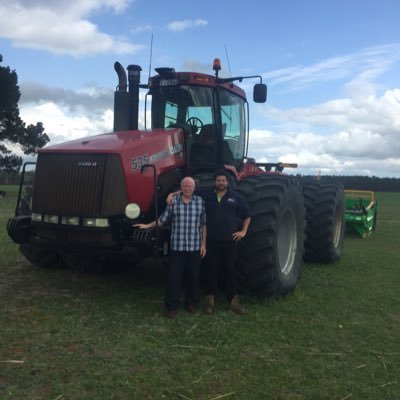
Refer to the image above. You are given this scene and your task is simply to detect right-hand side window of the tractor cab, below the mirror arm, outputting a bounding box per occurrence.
[220,91,246,165]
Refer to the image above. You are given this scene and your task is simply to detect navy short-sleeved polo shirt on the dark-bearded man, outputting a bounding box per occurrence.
[198,188,250,241]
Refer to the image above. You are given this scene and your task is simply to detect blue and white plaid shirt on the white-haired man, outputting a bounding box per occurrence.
[160,195,206,251]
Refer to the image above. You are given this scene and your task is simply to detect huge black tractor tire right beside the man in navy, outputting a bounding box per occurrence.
[237,174,305,297]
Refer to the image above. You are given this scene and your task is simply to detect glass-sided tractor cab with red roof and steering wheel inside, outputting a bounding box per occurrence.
[149,60,265,172]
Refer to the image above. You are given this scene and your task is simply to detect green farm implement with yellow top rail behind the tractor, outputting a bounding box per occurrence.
[344,190,378,238]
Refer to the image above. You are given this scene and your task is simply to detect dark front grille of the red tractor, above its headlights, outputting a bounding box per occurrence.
[32,153,127,217]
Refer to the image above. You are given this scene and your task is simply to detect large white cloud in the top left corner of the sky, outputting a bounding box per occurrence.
[0,0,143,56]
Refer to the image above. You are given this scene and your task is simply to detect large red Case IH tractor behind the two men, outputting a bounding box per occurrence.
[7,60,345,296]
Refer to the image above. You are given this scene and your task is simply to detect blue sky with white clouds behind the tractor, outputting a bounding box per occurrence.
[0,0,400,177]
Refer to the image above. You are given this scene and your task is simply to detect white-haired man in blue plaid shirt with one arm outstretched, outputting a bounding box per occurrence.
[134,177,207,318]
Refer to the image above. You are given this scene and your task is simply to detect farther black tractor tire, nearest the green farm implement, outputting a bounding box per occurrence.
[303,182,345,264]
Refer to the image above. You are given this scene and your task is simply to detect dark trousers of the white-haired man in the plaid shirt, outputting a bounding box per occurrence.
[165,250,201,311]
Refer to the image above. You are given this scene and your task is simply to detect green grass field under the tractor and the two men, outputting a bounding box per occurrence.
[0,187,400,400]
